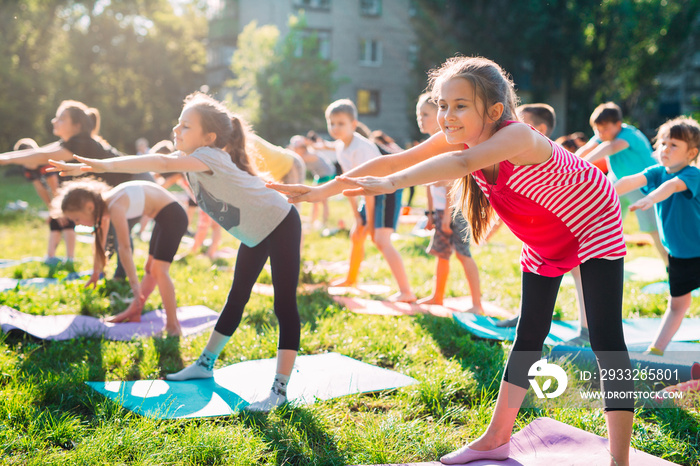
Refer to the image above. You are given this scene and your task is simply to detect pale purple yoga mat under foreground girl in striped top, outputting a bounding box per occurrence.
[356,417,675,466]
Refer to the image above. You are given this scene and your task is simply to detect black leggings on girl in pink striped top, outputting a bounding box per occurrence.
[503,259,634,411]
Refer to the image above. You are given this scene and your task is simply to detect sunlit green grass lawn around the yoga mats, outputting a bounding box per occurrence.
[0,172,700,465]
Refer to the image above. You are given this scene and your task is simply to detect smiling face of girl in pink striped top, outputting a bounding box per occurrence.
[437,77,500,146]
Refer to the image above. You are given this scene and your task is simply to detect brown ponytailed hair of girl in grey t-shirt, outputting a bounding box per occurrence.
[184,92,257,176]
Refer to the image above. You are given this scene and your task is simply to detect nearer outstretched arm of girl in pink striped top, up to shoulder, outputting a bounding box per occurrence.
[339,123,540,196]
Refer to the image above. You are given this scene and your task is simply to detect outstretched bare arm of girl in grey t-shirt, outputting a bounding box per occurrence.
[49,153,209,176]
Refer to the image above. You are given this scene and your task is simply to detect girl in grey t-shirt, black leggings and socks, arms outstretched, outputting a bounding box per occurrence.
[49,93,301,411]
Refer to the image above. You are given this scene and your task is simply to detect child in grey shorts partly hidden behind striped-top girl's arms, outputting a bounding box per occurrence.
[416,93,484,314]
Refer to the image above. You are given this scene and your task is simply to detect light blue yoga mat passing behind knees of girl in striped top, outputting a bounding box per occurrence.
[453,313,700,345]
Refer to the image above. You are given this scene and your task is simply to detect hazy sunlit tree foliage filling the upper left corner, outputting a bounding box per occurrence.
[0,0,207,152]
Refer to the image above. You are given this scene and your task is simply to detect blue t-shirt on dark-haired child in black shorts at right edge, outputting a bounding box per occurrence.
[642,165,700,259]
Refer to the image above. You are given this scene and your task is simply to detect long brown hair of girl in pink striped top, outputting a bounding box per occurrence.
[430,57,518,243]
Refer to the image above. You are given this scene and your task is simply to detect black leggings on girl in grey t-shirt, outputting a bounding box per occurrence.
[214,207,301,351]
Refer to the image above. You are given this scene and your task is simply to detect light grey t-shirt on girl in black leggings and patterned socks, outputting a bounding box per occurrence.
[186,147,292,247]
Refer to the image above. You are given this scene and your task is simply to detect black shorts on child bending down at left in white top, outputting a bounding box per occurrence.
[148,202,188,262]
